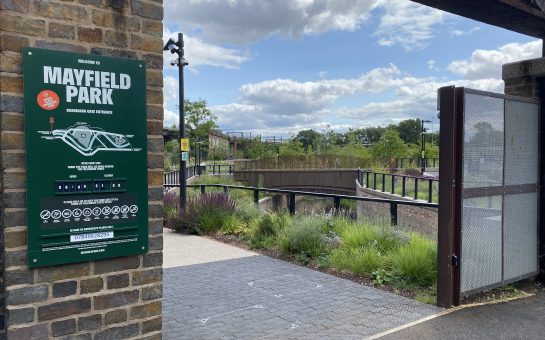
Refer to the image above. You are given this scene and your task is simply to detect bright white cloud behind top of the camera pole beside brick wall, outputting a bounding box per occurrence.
[163,30,250,71]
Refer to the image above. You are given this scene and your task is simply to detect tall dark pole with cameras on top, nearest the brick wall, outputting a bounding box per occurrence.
[163,33,189,210]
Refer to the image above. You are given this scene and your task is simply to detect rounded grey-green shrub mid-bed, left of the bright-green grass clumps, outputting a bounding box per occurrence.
[278,217,327,259]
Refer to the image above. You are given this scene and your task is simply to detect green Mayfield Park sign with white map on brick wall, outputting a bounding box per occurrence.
[23,48,148,267]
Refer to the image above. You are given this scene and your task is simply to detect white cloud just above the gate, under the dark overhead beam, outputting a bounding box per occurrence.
[448,40,542,79]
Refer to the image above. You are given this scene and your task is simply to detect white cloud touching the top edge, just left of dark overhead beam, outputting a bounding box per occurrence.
[374,0,448,51]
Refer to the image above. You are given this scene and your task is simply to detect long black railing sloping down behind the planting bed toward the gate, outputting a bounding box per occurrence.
[164,184,438,225]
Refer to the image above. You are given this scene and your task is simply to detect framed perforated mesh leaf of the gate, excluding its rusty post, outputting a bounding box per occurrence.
[460,89,539,295]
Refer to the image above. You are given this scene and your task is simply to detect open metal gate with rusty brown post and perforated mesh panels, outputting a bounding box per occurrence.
[437,87,540,307]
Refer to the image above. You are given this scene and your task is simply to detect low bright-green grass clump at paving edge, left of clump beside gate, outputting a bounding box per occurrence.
[330,247,384,275]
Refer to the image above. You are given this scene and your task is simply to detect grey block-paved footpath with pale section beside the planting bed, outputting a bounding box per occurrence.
[163,230,441,340]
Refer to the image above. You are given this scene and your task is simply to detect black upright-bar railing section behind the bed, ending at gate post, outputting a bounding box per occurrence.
[358,169,439,203]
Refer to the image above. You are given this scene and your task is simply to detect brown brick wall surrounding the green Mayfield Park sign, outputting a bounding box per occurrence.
[0,0,163,339]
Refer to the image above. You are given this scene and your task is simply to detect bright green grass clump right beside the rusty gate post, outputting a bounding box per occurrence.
[391,233,437,287]
